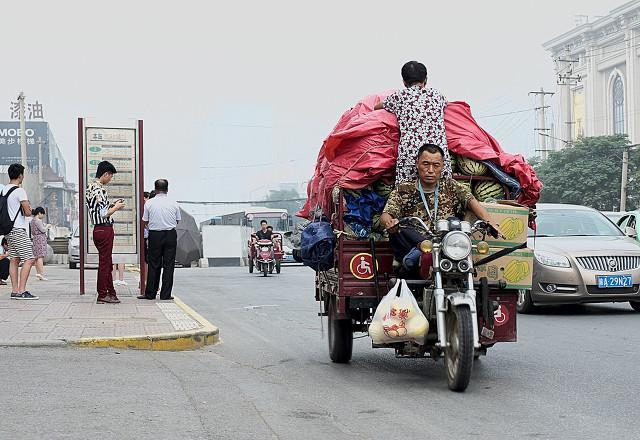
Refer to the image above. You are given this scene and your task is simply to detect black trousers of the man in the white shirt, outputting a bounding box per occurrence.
[144,229,178,299]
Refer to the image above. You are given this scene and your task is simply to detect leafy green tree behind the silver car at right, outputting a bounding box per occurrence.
[532,135,640,211]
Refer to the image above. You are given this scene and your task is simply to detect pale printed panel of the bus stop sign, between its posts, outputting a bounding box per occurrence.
[85,127,138,263]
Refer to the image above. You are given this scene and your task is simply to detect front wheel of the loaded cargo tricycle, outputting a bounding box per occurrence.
[444,305,475,391]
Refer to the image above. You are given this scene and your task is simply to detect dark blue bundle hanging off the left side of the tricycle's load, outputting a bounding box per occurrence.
[300,222,335,271]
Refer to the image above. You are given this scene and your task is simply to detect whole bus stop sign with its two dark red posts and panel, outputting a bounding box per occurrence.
[78,118,144,294]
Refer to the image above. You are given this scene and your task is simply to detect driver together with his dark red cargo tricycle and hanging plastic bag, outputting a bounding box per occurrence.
[314,144,530,391]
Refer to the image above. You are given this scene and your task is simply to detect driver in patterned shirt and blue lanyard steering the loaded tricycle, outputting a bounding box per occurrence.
[380,144,497,273]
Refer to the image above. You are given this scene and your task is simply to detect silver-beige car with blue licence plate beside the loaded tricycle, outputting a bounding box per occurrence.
[517,204,640,313]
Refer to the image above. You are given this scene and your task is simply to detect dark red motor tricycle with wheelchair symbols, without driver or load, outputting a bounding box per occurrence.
[316,190,518,391]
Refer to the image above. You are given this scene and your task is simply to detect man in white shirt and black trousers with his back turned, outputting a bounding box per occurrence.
[138,179,181,300]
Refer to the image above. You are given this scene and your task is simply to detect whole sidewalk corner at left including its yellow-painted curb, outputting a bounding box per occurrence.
[0,265,219,350]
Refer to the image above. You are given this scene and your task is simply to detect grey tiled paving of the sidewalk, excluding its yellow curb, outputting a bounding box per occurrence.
[0,266,201,345]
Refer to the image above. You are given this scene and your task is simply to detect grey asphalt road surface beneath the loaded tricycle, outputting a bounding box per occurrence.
[0,267,640,440]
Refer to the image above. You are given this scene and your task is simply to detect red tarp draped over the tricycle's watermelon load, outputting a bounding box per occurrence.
[298,93,542,218]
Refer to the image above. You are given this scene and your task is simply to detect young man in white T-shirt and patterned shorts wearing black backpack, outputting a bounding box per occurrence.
[0,163,38,300]
